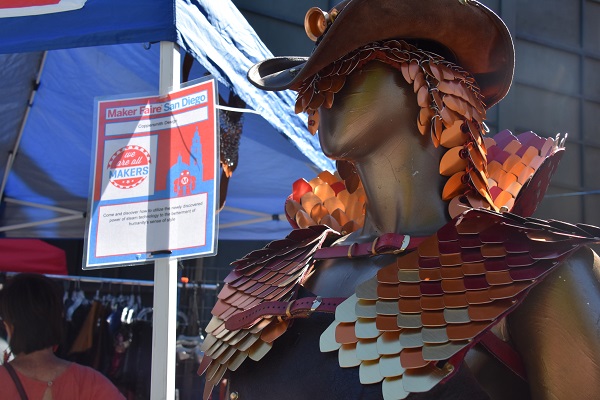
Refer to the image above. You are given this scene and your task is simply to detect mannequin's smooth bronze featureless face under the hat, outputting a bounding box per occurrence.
[319,61,420,161]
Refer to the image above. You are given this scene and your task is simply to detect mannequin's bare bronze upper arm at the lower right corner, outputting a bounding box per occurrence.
[509,248,600,400]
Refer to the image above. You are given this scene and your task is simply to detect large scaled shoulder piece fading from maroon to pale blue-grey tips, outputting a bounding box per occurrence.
[320,209,600,399]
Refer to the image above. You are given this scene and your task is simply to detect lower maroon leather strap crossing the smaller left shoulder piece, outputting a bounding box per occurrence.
[225,296,346,331]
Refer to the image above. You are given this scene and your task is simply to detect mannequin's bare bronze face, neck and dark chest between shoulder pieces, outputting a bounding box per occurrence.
[216,61,487,400]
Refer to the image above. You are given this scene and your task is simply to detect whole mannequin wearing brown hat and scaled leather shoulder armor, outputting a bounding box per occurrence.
[199,0,600,399]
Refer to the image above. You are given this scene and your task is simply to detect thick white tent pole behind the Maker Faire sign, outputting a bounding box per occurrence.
[150,42,181,400]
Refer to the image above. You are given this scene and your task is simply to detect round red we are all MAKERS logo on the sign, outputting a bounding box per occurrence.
[107,146,150,189]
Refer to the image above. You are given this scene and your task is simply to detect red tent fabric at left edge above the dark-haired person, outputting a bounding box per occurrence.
[0,239,67,275]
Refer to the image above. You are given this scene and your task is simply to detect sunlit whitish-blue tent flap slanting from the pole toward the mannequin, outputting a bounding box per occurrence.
[176,0,332,169]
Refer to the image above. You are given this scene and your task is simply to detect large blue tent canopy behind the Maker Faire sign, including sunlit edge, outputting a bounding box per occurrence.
[0,0,332,240]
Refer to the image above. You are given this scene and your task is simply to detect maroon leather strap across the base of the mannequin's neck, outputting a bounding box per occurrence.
[314,233,426,260]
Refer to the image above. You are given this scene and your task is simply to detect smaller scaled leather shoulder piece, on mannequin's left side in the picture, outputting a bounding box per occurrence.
[198,226,339,399]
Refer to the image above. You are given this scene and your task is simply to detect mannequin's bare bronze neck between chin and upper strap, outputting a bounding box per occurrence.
[355,132,448,236]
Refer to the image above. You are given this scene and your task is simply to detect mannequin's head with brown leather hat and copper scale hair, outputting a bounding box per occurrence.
[248,0,514,222]
